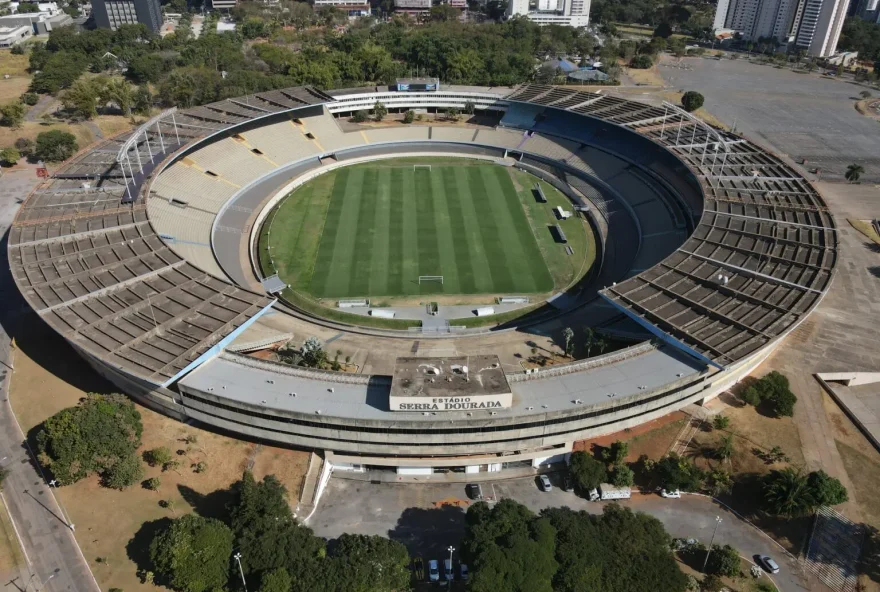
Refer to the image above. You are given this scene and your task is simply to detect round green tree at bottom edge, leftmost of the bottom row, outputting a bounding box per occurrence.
[150,514,232,592]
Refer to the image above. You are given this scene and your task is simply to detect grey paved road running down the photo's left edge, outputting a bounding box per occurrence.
[0,170,100,592]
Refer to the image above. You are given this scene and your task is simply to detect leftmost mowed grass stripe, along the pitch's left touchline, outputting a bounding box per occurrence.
[312,168,364,298]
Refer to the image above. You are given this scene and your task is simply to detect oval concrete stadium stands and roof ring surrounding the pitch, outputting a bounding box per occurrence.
[8,85,837,471]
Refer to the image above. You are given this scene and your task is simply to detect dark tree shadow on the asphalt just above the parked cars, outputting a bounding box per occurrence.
[388,505,466,561]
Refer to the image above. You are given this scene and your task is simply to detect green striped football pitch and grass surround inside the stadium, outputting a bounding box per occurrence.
[261,160,585,299]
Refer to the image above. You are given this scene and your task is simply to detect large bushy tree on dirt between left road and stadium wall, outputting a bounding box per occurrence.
[36,394,143,487]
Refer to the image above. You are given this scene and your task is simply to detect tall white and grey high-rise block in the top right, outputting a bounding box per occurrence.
[714,0,852,57]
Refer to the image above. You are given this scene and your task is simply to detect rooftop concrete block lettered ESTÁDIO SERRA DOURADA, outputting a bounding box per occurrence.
[389,355,513,413]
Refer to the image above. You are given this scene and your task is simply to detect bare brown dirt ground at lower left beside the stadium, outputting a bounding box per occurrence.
[10,325,309,592]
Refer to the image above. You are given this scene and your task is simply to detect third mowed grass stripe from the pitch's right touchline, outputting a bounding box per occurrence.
[447,167,495,294]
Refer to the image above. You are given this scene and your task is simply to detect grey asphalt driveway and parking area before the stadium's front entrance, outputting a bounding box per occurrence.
[308,477,807,592]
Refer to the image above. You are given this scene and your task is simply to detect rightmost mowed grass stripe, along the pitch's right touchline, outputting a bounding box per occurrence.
[483,167,553,292]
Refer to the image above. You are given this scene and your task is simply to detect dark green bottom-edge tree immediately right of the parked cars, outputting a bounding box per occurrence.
[462,498,558,592]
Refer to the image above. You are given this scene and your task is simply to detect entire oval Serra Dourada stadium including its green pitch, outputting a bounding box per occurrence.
[8,83,837,474]
